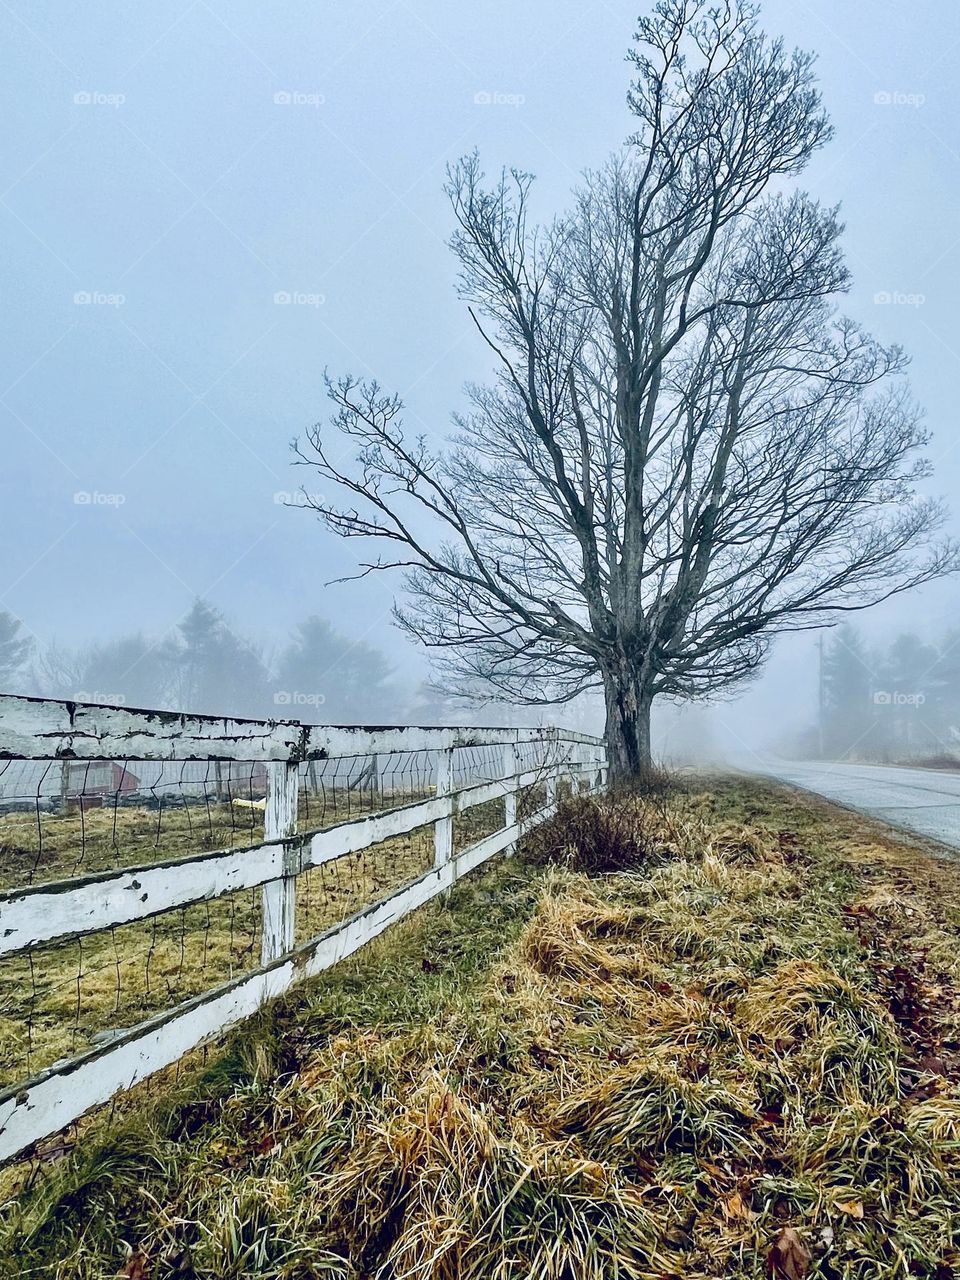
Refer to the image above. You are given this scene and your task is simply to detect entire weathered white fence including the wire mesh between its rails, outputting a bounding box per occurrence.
[0,695,605,1161]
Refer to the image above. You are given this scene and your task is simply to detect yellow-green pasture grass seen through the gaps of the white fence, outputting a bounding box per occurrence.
[0,792,514,1088]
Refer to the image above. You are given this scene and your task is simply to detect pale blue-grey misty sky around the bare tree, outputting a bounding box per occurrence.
[0,0,960,732]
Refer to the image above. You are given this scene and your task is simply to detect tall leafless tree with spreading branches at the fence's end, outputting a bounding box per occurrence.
[297,0,960,776]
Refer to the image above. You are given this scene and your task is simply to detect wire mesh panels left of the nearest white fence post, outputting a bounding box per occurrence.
[0,760,268,1087]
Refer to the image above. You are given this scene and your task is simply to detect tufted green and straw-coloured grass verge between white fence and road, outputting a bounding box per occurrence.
[0,780,960,1280]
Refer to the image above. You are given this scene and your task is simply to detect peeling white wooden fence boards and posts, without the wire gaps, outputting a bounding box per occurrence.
[0,695,605,1161]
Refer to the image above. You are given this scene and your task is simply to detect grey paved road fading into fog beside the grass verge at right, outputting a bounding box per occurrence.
[755,760,960,850]
